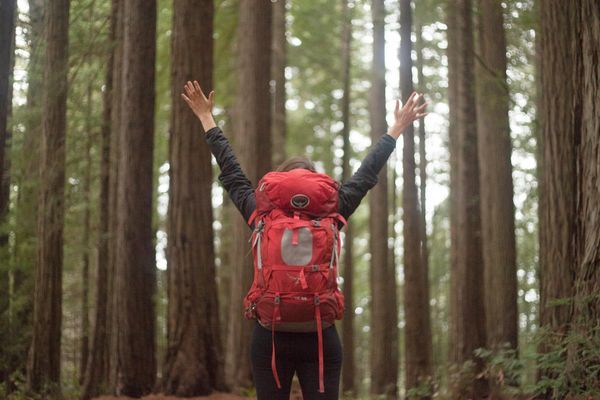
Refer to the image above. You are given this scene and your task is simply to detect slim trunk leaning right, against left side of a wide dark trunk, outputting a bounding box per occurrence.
[81,1,119,400]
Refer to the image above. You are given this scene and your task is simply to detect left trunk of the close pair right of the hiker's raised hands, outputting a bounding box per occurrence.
[448,0,487,398]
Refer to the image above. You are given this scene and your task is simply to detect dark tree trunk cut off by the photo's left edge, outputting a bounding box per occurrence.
[0,0,17,382]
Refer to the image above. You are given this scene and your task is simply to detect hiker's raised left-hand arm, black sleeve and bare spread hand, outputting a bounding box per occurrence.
[181,81,256,222]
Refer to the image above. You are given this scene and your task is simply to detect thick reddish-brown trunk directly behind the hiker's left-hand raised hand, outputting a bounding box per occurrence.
[161,0,224,397]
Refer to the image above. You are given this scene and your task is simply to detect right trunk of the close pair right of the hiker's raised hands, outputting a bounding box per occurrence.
[475,0,518,360]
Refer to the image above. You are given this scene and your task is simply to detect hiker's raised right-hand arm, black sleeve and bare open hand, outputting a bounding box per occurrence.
[339,92,427,219]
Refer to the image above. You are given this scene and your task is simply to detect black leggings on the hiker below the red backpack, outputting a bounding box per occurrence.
[250,322,342,400]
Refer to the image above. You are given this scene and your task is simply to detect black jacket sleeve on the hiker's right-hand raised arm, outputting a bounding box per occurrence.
[338,133,396,219]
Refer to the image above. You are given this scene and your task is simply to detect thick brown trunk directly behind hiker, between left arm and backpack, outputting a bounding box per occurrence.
[225,1,273,388]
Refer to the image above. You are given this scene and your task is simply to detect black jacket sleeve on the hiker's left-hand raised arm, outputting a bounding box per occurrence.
[206,127,256,223]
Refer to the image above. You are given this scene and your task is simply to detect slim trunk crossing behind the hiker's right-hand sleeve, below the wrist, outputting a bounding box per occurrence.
[369,0,398,398]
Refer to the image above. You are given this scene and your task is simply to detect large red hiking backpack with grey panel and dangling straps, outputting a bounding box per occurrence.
[244,168,346,392]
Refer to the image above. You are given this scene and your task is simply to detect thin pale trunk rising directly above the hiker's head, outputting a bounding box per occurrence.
[271,0,287,165]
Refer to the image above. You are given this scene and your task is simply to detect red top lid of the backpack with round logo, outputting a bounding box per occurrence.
[255,168,339,217]
